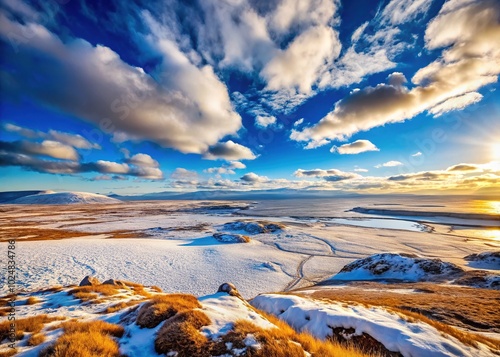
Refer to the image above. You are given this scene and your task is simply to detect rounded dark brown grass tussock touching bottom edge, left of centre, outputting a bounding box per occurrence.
[155,310,211,357]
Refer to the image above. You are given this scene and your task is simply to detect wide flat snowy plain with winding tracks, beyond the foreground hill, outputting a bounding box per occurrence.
[0,201,493,298]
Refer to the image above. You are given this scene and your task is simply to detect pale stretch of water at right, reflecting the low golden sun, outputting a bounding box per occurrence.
[241,195,500,242]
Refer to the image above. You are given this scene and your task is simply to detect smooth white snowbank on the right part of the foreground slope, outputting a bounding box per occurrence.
[252,294,494,357]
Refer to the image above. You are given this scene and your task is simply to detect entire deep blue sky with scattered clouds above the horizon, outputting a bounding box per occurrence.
[0,0,500,194]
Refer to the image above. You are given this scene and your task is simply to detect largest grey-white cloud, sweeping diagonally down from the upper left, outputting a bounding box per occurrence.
[0,7,241,153]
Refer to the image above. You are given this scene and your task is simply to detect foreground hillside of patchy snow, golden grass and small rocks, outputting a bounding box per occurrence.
[0,277,497,357]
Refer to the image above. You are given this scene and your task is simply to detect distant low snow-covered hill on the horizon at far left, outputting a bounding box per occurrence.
[8,192,121,205]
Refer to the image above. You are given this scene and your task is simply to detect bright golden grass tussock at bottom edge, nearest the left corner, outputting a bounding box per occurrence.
[39,320,124,357]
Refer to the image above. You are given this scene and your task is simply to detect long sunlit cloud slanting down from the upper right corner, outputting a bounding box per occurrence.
[290,0,500,142]
